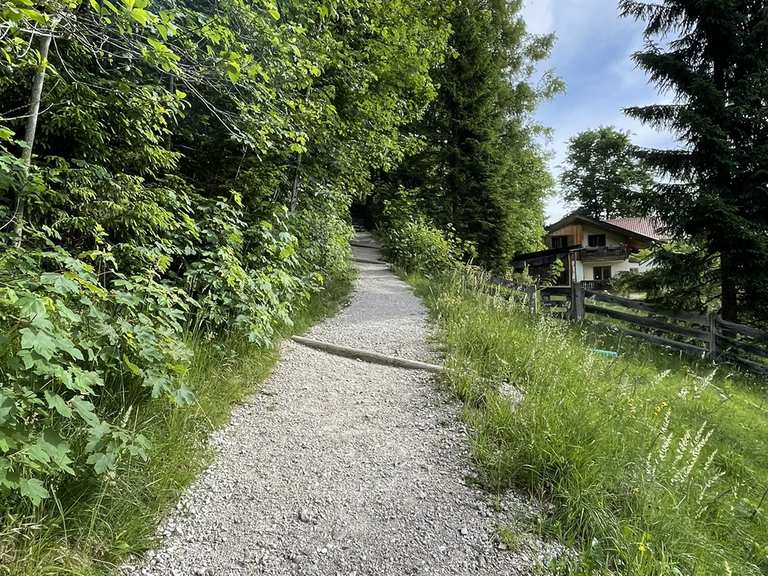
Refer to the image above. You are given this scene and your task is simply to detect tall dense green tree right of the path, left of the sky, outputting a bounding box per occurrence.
[388,0,562,268]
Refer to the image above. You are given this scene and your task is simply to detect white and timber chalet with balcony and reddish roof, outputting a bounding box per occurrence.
[512,214,665,290]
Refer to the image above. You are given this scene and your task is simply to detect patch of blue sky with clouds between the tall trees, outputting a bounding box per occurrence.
[523,0,672,223]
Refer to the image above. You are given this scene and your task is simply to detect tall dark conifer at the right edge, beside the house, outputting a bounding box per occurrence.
[621,0,768,320]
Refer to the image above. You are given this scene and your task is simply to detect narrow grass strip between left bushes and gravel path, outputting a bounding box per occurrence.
[0,281,351,576]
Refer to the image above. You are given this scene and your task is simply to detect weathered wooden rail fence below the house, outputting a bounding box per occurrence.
[494,279,768,375]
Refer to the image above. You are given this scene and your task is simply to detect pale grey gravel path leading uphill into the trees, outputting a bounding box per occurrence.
[125,237,536,576]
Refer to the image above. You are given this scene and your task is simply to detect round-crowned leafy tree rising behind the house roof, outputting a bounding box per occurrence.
[560,126,653,219]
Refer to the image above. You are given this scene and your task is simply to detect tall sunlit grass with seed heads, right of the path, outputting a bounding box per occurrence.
[411,276,768,576]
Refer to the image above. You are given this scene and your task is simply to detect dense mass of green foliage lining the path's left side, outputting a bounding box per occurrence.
[0,0,450,524]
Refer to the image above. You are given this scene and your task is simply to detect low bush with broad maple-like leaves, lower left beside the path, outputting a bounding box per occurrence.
[0,250,191,503]
